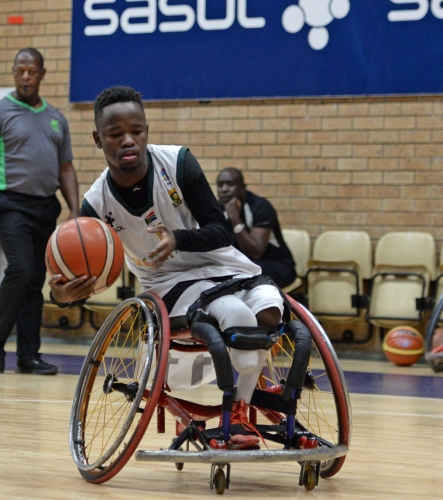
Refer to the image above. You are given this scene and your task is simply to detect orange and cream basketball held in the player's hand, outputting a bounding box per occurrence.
[46,217,124,294]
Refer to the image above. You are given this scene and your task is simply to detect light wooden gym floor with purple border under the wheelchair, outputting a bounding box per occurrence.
[0,343,443,500]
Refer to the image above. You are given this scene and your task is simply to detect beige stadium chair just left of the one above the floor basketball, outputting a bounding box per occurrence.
[307,230,372,323]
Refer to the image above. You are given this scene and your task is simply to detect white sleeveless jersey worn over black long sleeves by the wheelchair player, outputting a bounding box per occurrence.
[85,145,261,316]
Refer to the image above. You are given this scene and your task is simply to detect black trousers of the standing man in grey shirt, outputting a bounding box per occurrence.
[0,191,61,358]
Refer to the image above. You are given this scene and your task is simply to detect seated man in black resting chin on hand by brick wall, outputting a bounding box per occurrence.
[217,167,297,288]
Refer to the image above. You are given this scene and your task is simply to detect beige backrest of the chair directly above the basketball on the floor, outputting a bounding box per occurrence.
[374,231,437,280]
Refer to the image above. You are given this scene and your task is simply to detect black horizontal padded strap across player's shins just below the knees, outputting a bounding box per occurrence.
[221,326,280,351]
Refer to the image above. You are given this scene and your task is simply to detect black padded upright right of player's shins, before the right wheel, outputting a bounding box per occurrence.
[283,321,312,401]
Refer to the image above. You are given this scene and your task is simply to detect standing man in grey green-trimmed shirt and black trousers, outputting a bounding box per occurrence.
[0,47,79,375]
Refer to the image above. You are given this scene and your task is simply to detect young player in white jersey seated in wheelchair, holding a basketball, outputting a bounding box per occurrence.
[50,87,312,449]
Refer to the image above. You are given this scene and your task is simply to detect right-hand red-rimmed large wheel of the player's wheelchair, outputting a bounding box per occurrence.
[259,297,352,477]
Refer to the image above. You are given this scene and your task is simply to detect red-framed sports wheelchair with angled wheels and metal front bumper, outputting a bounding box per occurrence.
[69,292,352,494]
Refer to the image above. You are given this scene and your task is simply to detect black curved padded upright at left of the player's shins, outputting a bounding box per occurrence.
[191,322,234,391]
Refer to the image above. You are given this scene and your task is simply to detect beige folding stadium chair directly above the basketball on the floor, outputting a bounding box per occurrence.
[367,231,437,328]
